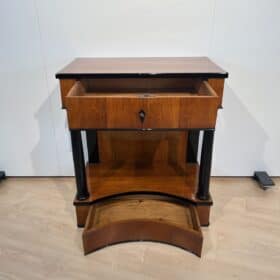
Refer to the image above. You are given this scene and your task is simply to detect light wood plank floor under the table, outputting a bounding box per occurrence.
[0,178,280,280]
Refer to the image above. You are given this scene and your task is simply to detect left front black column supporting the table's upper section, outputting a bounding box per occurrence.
[70,130,89,200]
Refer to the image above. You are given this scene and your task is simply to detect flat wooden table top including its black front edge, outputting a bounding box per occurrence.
[56,57,228,79]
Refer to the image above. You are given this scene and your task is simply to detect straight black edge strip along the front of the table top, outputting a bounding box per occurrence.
[55,72,228,79]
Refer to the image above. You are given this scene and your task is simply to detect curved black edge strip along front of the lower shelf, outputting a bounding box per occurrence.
[73,191,213,206]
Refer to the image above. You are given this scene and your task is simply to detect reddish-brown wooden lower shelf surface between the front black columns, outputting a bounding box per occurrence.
[75,162,199,205]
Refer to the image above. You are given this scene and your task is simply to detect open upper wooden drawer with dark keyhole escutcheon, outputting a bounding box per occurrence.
[66,80,219,129]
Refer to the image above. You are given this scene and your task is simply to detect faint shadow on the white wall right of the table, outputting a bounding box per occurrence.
[212,82,268,176]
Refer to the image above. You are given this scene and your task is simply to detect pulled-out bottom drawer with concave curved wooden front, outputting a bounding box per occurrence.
[83,195,203,256]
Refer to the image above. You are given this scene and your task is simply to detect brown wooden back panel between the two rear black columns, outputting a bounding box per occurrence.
[98,131,188,164]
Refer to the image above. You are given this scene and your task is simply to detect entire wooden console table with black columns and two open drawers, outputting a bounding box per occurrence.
[56,57,228,256]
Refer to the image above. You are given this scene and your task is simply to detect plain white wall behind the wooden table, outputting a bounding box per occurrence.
[0,0,280,176]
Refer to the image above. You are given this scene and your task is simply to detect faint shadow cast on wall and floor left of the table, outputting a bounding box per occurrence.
[31,85,76,217]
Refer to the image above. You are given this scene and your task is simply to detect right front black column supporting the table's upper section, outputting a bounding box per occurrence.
[197,129,214,200]
